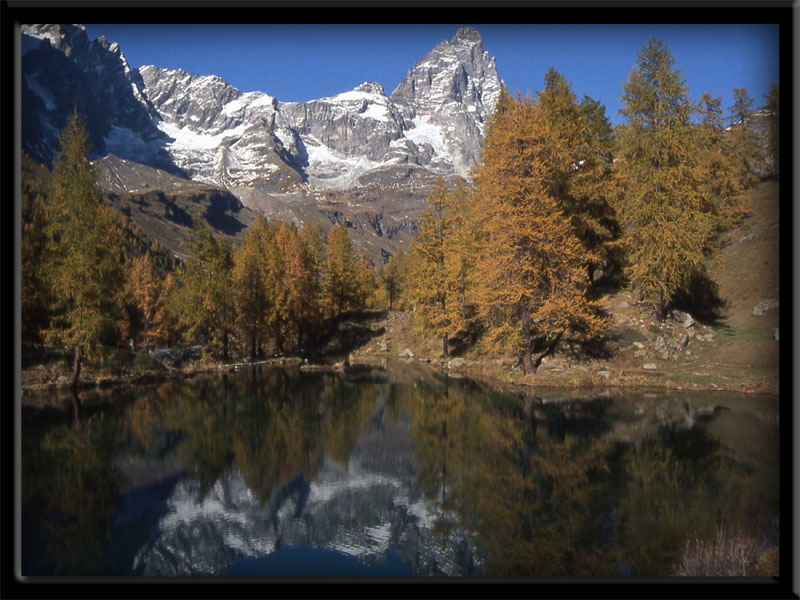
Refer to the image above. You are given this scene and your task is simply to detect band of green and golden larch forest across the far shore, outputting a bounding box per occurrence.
[21,38,780,385]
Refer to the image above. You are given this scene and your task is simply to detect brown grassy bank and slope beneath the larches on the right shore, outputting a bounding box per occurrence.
[351,181,780,394]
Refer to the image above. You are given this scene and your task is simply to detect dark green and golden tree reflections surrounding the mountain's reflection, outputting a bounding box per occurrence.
[23,369,777,575]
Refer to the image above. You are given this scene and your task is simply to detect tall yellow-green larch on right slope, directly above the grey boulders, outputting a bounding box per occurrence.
[618,38,715,319]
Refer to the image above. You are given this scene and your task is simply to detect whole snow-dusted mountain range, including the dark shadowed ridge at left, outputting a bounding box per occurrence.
[22,25,502,257]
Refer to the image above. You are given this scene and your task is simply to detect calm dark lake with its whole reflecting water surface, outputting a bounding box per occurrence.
[22,364,779,577]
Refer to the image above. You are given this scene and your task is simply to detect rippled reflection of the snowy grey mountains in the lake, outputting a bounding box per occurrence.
[133,412,482,575]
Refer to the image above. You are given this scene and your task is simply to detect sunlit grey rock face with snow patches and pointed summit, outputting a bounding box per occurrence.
[133,28,501,189]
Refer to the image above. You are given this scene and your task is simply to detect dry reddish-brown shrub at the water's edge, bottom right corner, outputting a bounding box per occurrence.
[676,528,777,577]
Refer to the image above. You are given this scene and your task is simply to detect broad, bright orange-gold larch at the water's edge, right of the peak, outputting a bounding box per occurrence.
[473,91,606,374]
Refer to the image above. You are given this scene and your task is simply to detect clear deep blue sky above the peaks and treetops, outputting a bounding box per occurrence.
[86,23,779,122]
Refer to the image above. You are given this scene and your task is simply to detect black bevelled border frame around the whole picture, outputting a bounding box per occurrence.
[0,0,800,599]
